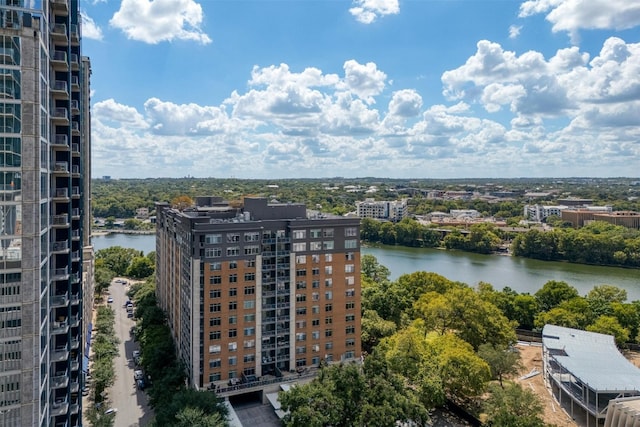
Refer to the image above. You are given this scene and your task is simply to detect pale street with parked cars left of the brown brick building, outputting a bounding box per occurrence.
[109,281,153,427]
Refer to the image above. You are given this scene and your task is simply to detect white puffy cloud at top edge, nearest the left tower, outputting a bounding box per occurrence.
[109,0,211,44]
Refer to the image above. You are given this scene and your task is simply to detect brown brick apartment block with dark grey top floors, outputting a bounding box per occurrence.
[156,197,360,388]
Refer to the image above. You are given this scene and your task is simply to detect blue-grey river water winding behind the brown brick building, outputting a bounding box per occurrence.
[92,234,640,301]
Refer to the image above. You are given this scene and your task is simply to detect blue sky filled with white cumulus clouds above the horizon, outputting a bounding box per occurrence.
[81,0,640,179]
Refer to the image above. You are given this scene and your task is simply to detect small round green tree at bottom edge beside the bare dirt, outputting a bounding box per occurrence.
[483,382,546,427]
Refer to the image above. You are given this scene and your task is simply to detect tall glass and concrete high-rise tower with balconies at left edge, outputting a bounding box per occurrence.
[0,0,92,427]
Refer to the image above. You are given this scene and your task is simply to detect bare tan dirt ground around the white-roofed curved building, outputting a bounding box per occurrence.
[516,344,640,427]
